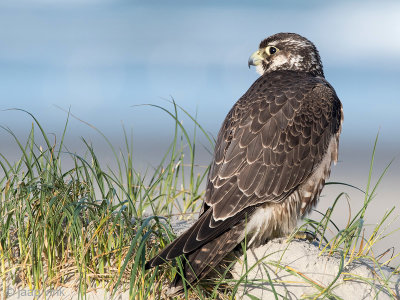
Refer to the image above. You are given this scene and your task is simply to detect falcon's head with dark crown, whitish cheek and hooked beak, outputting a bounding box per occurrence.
[249,33,324,76]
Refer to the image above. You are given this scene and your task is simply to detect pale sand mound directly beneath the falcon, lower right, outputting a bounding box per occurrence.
[233,239,400,300]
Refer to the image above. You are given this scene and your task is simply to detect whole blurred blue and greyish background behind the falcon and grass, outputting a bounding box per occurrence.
[0,0,400,252]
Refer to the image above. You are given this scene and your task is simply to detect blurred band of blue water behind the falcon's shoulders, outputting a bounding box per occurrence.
[0,59,400,143]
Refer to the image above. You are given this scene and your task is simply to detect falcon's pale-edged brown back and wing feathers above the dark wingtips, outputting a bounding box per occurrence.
[205,71,341,220]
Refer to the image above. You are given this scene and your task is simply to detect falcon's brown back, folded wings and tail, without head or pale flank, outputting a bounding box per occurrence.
[146,71,341,289]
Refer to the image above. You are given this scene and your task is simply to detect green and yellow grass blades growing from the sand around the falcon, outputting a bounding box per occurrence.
[0,102,393,299]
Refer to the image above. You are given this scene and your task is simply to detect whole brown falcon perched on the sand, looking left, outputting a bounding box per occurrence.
[146,33,343,294]
